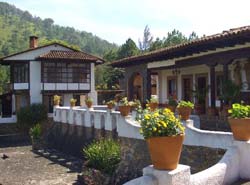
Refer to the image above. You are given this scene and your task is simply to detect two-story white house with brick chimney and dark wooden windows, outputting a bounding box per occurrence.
[0,36,104,122]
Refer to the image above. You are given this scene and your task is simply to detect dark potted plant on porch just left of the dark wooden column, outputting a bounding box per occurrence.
[192,85,209,115]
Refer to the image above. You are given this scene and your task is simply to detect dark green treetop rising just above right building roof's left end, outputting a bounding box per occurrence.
[117,38,139,59]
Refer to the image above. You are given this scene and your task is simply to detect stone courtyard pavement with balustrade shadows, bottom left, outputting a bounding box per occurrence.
[0,146,82,185]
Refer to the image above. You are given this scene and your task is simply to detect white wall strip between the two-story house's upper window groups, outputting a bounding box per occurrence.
[30,61,42,104]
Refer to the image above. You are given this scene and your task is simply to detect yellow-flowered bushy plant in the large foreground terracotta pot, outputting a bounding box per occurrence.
[138,109,184,139]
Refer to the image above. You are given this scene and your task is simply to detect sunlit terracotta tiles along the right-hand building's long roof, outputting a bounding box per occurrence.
[111,26,250,66]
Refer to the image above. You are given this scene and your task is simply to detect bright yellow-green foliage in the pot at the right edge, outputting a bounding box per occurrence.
[228,103,250,119]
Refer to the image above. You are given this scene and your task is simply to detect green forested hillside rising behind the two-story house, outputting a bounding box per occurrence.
[0,2,117,57]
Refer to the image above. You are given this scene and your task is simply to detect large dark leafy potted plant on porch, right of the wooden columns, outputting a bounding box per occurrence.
[219,80,240,116]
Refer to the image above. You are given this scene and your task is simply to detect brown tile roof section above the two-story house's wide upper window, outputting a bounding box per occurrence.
[37,50,104,63]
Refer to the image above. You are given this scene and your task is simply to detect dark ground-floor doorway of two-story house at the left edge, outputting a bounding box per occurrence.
[0,93,12,118]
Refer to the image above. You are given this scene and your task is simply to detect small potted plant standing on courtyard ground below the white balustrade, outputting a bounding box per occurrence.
[29,124,42,150]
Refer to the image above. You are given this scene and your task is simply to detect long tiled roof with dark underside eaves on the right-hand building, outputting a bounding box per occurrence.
[111,26,250,67]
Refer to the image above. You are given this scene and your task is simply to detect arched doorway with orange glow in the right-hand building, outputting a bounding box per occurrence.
[128,73,143,102]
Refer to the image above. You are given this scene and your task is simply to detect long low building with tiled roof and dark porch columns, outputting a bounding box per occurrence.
[112,26,250,113]
